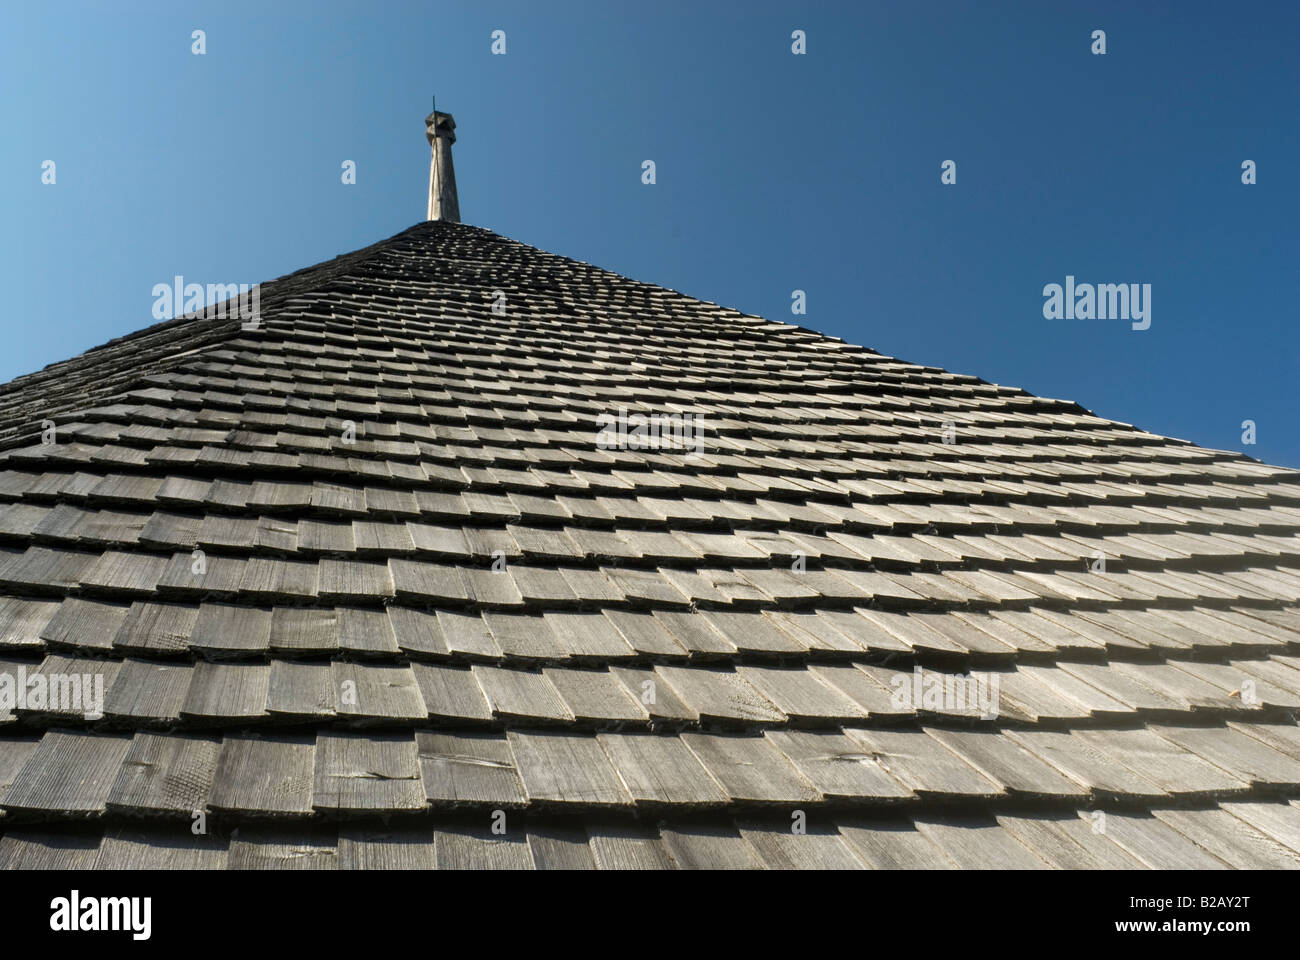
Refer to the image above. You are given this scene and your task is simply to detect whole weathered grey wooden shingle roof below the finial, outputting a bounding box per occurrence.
[0,221,1300,868]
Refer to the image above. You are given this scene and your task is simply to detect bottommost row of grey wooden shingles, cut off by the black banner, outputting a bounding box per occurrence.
[0,801,1300,870]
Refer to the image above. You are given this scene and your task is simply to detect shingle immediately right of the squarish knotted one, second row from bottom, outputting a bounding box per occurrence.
[415,730,527,808]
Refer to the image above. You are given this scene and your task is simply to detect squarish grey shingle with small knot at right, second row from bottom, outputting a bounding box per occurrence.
[312,731,426,816]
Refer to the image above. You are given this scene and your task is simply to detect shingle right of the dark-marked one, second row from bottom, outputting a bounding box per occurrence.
[508,730,632,807]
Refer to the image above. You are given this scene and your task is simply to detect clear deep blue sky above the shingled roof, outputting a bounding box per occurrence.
[0,0,1300,466]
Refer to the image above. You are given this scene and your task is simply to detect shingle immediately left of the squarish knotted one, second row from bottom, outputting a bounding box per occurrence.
[208,735,316,816]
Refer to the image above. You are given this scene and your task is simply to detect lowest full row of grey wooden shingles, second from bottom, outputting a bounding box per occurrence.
[0,721,1300,825]
